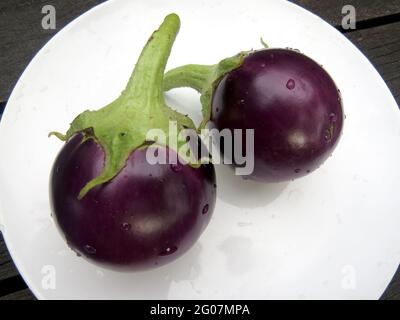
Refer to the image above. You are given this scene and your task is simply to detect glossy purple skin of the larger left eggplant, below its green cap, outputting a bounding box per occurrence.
[50,134,216,271]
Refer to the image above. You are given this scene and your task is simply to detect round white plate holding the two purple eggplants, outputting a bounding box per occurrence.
[0,0,400,299]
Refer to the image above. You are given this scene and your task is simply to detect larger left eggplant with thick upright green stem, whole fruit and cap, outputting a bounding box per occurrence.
[50,14,216,270]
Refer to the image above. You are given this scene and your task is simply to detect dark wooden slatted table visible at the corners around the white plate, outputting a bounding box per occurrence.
[0,0,400,300]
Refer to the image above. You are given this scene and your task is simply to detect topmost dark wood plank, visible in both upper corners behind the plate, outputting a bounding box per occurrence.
[0,0,400,101]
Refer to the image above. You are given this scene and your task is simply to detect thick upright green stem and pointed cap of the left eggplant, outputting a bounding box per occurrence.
[51,14,195,199]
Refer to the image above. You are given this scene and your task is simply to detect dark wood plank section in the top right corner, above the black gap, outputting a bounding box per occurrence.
[292,0,400,26]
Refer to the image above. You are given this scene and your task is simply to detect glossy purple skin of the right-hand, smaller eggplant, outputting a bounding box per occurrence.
[211,49,344,182]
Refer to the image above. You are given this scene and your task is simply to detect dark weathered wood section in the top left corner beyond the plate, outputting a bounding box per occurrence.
[0,0,105,101]
